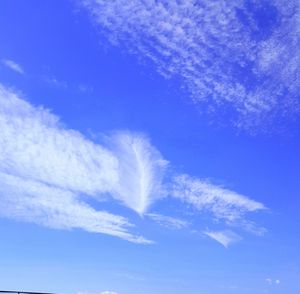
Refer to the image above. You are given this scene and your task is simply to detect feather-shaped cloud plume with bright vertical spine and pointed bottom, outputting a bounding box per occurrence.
[110,132,167,214]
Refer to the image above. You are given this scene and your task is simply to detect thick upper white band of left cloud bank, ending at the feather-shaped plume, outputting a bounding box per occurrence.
[0,87,118,195]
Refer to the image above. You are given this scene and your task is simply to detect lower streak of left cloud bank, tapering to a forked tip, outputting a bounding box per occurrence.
[0,173,149,243]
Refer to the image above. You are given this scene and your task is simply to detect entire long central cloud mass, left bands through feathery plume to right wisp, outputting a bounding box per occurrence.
[0,84,264,244]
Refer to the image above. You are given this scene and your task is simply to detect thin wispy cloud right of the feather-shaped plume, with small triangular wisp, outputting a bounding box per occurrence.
[170,175,267,247]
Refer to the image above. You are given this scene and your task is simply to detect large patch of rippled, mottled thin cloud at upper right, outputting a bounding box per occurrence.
[79,0,300,128]
